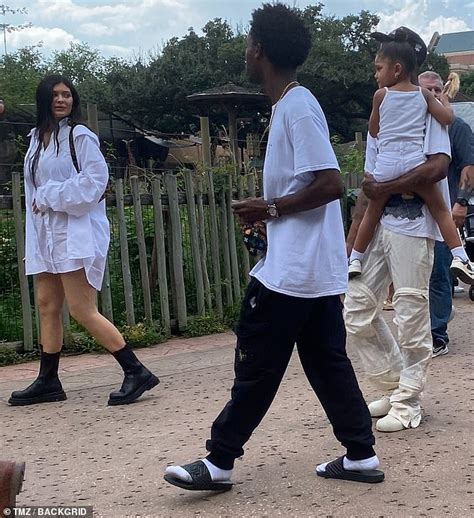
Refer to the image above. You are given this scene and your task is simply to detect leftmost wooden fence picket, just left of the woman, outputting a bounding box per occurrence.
[12,171,33,351]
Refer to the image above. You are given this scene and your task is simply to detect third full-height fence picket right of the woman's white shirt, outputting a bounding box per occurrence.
[151,178,171,335]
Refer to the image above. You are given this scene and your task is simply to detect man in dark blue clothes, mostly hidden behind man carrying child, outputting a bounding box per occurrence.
[418,71,474,358]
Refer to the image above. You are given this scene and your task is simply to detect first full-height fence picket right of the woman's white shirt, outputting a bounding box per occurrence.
[115,178,135,326]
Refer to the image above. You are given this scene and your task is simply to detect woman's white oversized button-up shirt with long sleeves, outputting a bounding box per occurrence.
[24,119,110,290]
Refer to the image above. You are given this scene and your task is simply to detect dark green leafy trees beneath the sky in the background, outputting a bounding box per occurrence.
[0,3,448,140]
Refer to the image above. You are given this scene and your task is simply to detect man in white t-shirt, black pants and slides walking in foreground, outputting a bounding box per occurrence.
[165,4,384,490]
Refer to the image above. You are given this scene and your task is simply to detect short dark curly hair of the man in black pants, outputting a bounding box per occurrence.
[250,4,311,70]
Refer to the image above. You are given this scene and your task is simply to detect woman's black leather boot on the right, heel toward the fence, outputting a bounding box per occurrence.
[109,344,160,405]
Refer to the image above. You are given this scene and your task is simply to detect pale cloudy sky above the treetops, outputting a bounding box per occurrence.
[4,0,474,57]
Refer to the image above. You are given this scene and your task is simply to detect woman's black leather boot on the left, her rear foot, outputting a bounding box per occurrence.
[8,351,67,406]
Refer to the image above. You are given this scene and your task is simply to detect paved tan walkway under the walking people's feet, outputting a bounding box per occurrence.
[0,294,474,518]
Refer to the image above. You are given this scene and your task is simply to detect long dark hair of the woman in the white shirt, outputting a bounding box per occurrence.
[29,74,81,187]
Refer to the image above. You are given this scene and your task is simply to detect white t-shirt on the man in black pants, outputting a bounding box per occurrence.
[250,87,348,298]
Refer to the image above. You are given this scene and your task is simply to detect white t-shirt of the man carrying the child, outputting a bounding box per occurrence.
[365,114,451,241]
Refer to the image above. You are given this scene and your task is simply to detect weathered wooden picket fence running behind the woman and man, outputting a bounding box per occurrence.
[0,166,360,350]
